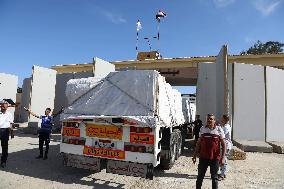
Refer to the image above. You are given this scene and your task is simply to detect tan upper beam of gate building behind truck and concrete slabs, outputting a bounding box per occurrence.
[51,53,284,86]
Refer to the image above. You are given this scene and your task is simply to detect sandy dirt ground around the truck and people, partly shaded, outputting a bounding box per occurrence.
[0,131,284,189]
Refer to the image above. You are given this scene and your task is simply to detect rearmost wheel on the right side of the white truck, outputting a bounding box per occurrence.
[161,130,178,170]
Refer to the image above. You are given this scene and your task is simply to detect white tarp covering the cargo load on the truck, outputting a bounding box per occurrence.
[61,70,184,127]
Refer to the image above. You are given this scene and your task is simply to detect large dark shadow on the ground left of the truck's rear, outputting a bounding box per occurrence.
[0,144,124,189]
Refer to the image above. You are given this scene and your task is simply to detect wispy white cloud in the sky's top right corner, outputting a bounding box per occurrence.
[252,0,283,16]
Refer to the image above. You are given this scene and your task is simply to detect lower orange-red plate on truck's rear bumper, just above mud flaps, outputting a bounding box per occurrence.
[83,146,125,159]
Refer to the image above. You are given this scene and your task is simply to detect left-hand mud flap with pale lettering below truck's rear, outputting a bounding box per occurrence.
[64,154,101,172]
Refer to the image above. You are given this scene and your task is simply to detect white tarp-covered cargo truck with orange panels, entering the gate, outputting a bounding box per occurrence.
[60,70,185,179]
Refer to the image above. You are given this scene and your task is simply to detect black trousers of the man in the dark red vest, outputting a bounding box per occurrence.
[196,158,219,189]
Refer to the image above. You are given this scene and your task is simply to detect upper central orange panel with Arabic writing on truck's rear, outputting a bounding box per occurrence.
[86,124,122,140]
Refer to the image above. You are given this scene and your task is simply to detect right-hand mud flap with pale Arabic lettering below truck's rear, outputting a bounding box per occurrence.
[106,160,153,179]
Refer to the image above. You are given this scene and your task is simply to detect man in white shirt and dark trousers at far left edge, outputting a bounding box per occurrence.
[0,100,13,168]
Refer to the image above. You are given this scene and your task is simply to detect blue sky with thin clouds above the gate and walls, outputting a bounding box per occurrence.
[0,0,284,93]
